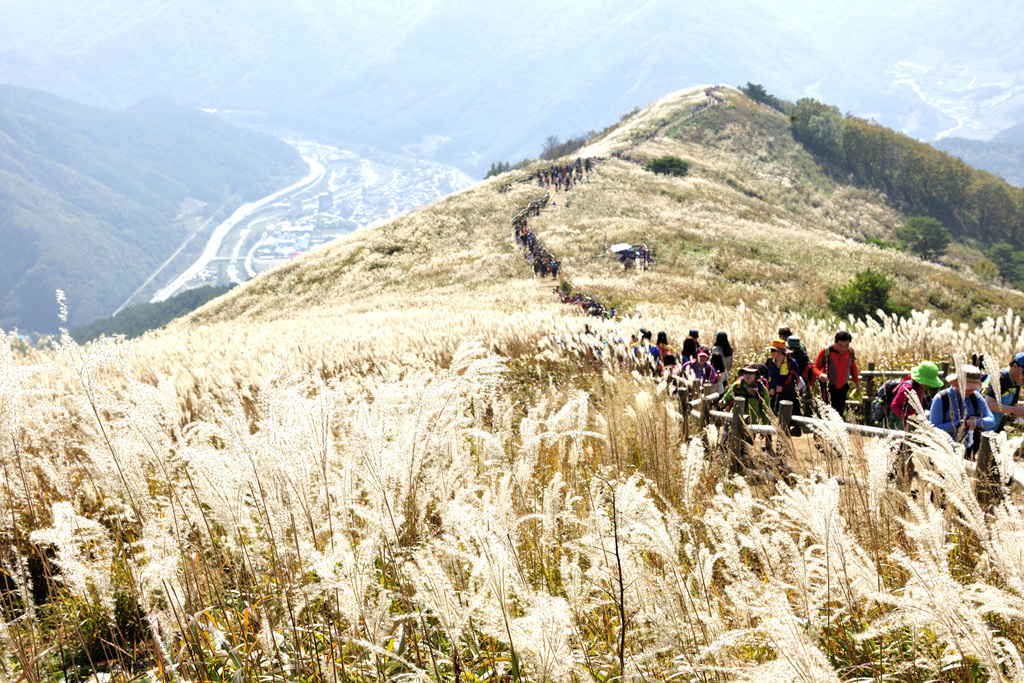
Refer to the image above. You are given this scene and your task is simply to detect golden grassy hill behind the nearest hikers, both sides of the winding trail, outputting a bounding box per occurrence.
[110,87,1024,413]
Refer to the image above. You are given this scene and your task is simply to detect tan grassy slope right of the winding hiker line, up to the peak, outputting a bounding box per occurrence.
[537,89,1024,324]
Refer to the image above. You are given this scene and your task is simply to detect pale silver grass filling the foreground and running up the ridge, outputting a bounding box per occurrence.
[0,89,1024,683]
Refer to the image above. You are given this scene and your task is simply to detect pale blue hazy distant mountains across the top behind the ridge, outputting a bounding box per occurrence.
[0,0,1024,173]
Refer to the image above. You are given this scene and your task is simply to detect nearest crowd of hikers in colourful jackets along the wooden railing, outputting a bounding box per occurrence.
[630,327,1024,453]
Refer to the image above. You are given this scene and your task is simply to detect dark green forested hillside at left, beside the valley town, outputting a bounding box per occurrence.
[0,87,304,331]
